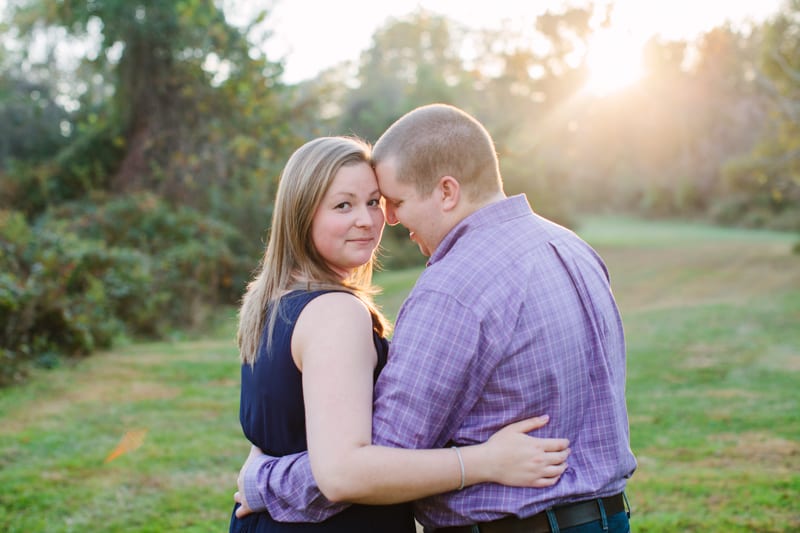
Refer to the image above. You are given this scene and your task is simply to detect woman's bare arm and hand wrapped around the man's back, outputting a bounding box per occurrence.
[292,293,569,504]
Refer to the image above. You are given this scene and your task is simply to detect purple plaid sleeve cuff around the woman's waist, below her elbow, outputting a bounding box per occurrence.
[244,452,349,522]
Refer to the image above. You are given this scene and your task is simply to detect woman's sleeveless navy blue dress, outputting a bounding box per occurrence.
[230,291,415,533]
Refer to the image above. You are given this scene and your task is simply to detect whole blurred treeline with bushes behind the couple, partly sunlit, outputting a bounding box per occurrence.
[0,0,800,382]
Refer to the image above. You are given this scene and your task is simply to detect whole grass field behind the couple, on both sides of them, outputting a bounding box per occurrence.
[0,218,800,533]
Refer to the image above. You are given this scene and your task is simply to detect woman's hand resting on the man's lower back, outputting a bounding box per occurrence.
[480,415,570,488]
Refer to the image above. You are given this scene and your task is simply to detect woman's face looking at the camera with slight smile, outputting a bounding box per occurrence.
[311,163,384,279]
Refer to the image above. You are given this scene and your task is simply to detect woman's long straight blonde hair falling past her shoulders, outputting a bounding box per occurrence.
[237,137,389,364]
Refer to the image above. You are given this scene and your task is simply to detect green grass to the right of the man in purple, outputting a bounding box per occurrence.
[579,218,800,532]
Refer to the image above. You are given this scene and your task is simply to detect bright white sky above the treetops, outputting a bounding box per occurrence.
[224,0,781,83]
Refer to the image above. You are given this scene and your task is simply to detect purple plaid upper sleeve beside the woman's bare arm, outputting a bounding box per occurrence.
[373,290,493,448]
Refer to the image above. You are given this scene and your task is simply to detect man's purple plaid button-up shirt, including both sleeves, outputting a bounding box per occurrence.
[245,196,636,527]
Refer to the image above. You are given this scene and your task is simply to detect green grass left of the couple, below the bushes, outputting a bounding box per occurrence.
[0,340,247,533]
